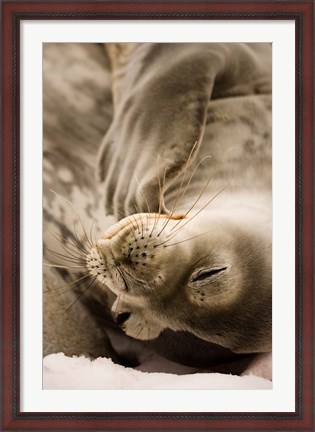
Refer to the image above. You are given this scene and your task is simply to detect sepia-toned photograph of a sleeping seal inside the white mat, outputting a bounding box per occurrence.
[43,43,272,389]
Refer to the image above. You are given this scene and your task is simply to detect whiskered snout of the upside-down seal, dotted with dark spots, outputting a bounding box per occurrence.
[86,213,190,296]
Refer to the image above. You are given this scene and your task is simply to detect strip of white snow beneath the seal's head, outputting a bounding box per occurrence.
[43,353,272,390]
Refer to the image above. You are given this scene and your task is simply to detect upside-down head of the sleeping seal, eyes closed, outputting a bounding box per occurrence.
[86,202,271,353]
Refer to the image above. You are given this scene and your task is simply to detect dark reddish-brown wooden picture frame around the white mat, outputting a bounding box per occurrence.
[1,0,314,431]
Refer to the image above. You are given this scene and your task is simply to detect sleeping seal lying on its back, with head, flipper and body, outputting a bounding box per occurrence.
[86,44,272,366]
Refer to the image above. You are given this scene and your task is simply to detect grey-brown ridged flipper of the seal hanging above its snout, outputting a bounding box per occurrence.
[98,44,269,219]
